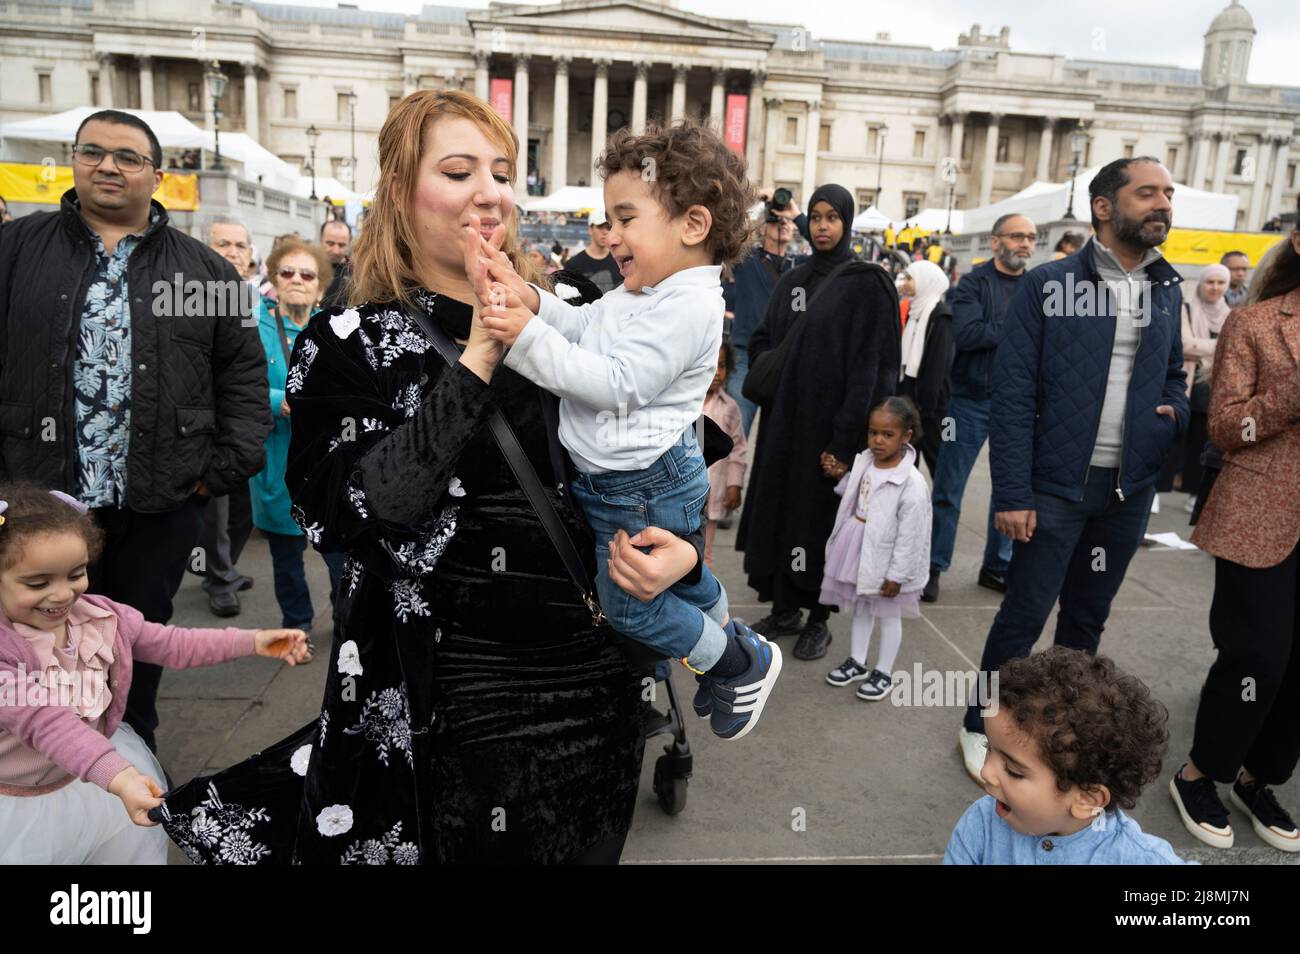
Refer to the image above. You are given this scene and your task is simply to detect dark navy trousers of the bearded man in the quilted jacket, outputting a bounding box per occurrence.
[966,467,1156,732]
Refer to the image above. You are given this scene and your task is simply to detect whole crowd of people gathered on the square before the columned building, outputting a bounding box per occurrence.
[0,97,1300,864]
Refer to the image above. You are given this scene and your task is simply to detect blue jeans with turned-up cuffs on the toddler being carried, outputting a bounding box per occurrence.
[573,429,727,671]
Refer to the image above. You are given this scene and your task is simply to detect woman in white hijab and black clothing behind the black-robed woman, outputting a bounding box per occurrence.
[898,261,953,476]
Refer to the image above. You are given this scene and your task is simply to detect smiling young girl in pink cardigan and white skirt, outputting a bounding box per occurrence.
[0,483,311,864]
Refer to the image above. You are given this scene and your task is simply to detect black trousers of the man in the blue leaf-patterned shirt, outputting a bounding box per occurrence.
[88,495,208,751]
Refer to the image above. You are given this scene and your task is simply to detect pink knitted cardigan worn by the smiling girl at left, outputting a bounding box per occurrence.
[0,595,256,790]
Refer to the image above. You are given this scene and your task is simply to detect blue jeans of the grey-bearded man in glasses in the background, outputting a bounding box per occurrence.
[930,395,1011,574]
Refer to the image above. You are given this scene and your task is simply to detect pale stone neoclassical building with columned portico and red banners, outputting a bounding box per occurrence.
[0,0,1300,229]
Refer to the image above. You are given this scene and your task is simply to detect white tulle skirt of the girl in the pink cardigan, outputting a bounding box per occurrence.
[0,723,166,864]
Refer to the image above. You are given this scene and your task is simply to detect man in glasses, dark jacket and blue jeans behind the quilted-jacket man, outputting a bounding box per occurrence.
[920,214,1039,603]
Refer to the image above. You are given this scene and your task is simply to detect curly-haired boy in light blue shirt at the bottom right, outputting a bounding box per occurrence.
[944,646,1186,864]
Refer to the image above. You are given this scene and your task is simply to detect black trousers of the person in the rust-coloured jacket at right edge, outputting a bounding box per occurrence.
[1191,546,1300,785]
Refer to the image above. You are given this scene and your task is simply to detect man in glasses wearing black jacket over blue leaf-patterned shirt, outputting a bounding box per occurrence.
[0,109,272,749]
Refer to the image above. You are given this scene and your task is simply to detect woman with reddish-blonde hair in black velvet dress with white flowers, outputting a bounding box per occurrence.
[168,91,717,864]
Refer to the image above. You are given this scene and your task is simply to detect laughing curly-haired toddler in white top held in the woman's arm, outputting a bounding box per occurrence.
[465,121,781,738]
